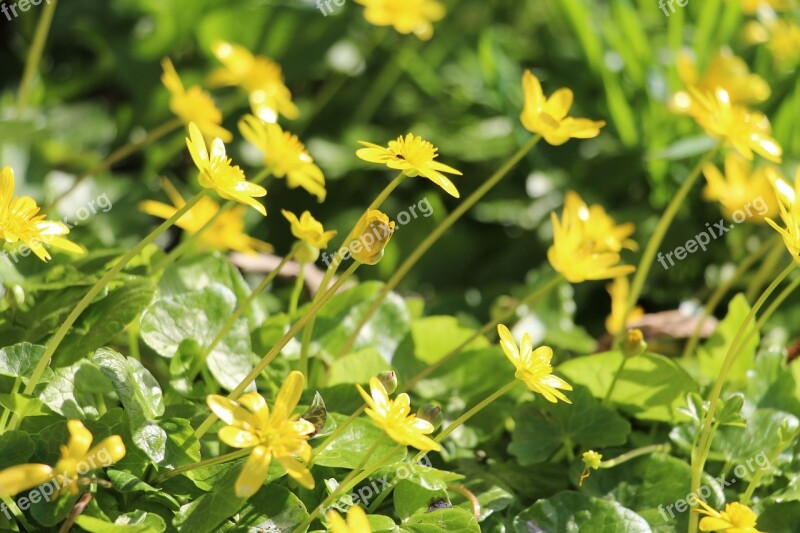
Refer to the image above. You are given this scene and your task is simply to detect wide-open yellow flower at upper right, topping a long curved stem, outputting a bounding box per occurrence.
[689,88,783,163]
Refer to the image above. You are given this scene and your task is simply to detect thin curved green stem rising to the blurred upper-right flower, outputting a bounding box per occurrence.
[611,148,719,346]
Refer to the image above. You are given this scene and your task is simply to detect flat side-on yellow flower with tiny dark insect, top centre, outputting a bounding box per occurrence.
[356,133,461,198]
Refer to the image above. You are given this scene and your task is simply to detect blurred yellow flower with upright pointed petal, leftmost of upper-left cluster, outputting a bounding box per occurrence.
[161,59,233,142]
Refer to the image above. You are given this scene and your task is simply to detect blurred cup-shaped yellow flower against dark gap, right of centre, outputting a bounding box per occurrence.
[547,191,636,283]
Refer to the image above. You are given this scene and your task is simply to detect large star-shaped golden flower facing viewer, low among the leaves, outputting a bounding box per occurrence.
[206,371,314,498]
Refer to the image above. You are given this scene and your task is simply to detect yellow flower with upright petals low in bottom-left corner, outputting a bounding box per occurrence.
[55,420,125,495]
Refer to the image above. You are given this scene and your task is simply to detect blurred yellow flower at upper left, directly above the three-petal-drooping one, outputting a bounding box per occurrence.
[209,41,300,122]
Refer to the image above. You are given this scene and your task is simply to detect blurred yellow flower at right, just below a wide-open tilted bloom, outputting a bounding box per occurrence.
[703,152,780,222]
